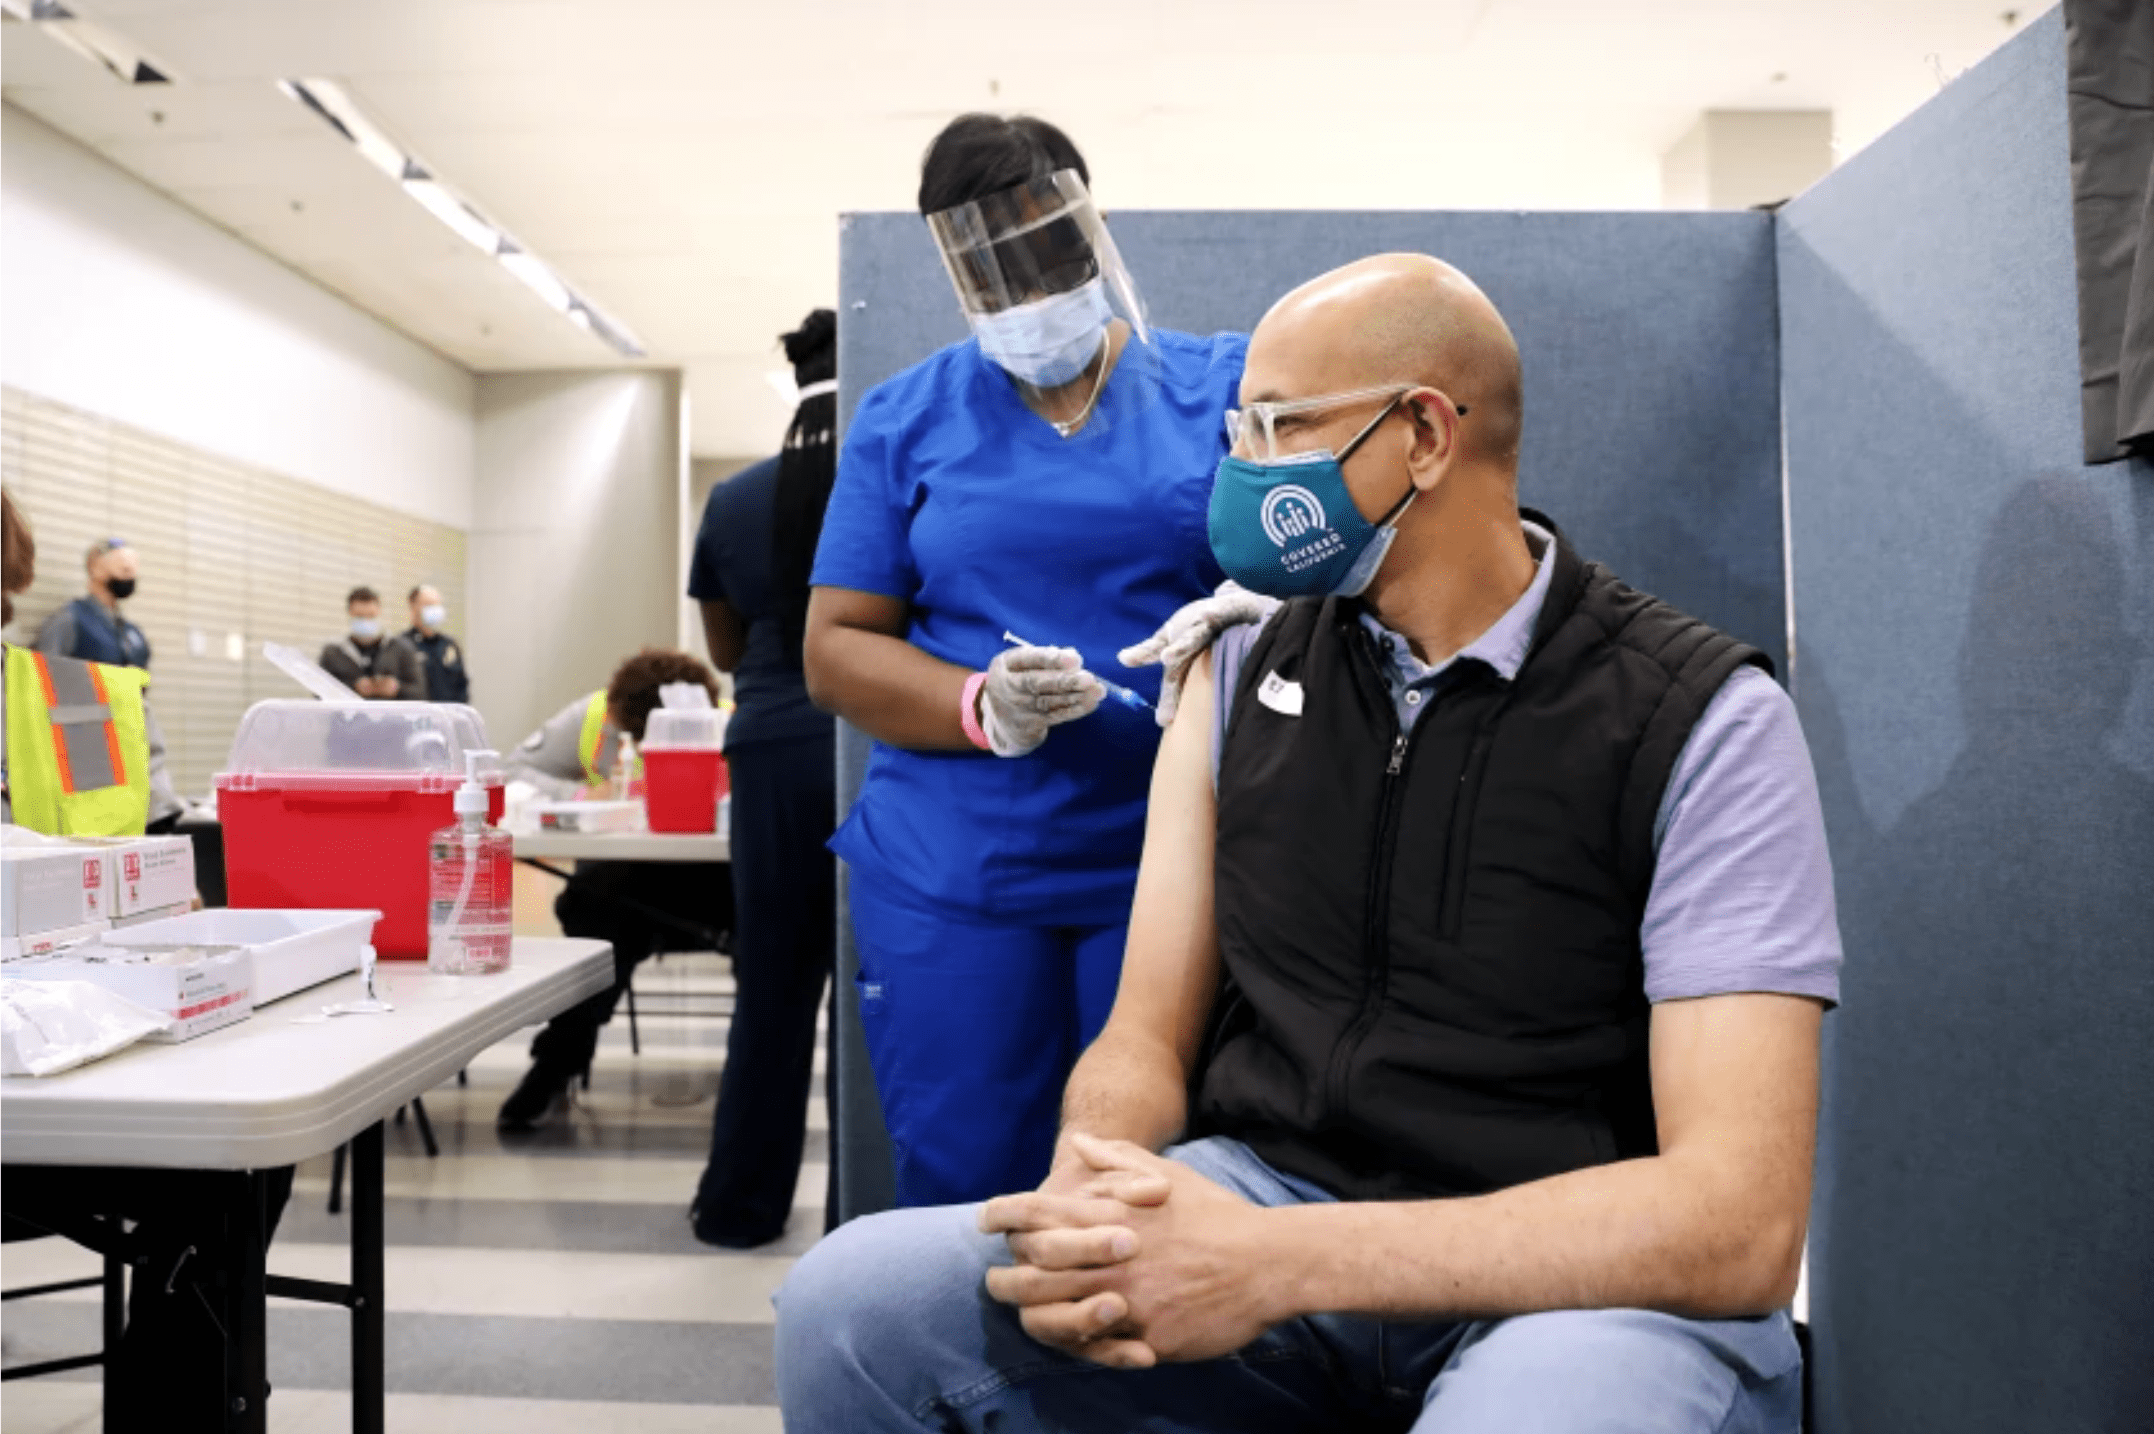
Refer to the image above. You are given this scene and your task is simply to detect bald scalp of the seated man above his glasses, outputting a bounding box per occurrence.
[1245,254,1523,465]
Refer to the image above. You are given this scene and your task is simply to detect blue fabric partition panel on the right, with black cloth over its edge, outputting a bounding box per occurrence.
[1779,11,2154,1434]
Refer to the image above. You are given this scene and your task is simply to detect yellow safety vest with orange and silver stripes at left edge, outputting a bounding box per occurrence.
[6,646,149,835]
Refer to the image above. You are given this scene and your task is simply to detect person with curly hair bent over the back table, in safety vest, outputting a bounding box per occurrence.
[498,648,732,1133]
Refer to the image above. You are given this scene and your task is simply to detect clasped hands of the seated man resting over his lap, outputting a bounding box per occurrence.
[980,1133,1290,1369]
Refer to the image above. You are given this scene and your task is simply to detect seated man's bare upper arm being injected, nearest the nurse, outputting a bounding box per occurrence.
[1107,652,1219,1072]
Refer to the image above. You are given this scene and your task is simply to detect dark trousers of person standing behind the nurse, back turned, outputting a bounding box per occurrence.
[696,736,838,1245]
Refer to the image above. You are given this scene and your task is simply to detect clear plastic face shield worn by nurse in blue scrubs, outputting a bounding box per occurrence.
[928,170,1159,437]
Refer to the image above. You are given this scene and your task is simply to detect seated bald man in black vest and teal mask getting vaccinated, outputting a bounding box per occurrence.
[778,254,1840,1434]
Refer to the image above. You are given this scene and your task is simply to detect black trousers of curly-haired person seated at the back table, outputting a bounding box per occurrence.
[532,861,732,1079]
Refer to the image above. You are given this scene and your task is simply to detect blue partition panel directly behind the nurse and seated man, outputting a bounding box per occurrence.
[838,206,1786,1217]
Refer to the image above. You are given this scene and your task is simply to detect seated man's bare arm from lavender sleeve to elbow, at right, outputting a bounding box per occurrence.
[1652,993,1824,1292]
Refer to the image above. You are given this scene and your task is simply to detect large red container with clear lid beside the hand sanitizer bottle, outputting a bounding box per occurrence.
[215,700,502,960]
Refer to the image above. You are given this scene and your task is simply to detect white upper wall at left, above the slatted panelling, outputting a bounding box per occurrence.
[0,106,474,528]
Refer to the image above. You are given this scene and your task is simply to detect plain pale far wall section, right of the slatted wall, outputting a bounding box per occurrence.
[463,370,685,747]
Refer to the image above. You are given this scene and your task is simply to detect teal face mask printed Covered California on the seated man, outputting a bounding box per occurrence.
[1208,394,1419,599]
